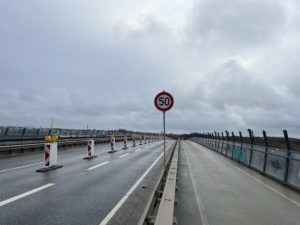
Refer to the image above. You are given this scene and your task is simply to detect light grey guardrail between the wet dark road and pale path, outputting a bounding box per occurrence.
[155,141,180,225]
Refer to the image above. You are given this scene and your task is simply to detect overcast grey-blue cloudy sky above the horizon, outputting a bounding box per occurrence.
[0,0,300,136]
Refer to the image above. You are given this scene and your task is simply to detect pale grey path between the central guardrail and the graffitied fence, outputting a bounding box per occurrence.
[176,141,300,225]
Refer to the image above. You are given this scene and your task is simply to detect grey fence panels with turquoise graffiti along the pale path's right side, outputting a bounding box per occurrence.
[189,137,300,191]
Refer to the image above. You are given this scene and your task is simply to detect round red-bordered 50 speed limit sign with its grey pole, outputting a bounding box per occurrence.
[154,91,174,170]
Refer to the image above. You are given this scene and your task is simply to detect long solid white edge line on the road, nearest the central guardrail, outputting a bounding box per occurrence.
[99,153,163,225]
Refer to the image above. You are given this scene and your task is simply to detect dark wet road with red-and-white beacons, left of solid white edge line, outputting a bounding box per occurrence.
[0,141,174,225]
